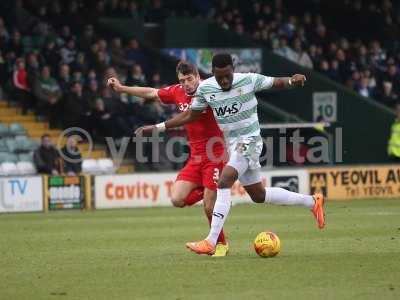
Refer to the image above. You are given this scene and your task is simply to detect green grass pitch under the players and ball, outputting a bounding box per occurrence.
[0,200,400,300]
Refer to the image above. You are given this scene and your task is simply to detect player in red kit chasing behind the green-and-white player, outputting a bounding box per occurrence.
[107,61,229,256]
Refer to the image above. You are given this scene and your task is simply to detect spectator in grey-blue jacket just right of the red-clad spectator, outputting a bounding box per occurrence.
[33,66,62,127]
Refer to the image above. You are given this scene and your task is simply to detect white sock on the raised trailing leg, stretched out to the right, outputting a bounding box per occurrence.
[265,187,314,207]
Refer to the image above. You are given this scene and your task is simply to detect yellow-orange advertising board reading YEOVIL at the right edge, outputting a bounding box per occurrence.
[309,165,400,200]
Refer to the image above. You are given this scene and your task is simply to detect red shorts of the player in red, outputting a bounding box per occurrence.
[176,157,225,191]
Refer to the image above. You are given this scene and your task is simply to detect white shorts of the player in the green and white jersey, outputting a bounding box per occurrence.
[227,136,263,186]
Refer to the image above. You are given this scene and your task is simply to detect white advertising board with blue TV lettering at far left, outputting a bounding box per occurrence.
[0,176,43,212]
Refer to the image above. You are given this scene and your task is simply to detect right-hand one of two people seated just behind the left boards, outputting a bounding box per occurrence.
[61,135,82,176]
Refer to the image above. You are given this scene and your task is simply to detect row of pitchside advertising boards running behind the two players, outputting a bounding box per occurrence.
[0,164,400,213]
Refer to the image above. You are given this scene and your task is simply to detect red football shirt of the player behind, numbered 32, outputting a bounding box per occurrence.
[158,84,224,156]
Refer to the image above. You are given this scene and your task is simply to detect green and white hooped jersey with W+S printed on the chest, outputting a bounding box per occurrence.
[192,73,274,143]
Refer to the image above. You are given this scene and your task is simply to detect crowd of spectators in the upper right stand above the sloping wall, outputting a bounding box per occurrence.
[209,0,400,107]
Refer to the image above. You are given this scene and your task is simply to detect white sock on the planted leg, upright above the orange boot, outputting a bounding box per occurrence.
[206,189,231,246]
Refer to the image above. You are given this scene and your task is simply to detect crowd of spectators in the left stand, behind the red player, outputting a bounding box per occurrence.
[0,1,172,143]
